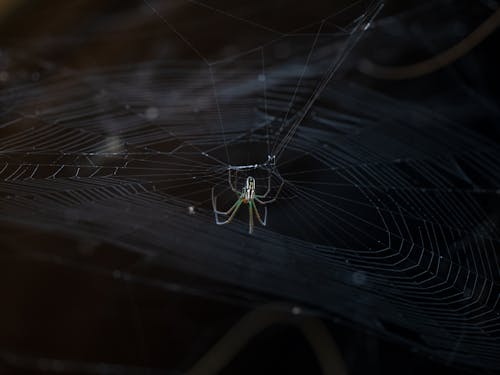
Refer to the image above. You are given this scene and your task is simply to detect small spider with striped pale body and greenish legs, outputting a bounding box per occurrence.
[212,170,284,234]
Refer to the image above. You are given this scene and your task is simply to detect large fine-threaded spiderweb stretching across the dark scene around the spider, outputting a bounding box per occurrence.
[0,0,500,369]
